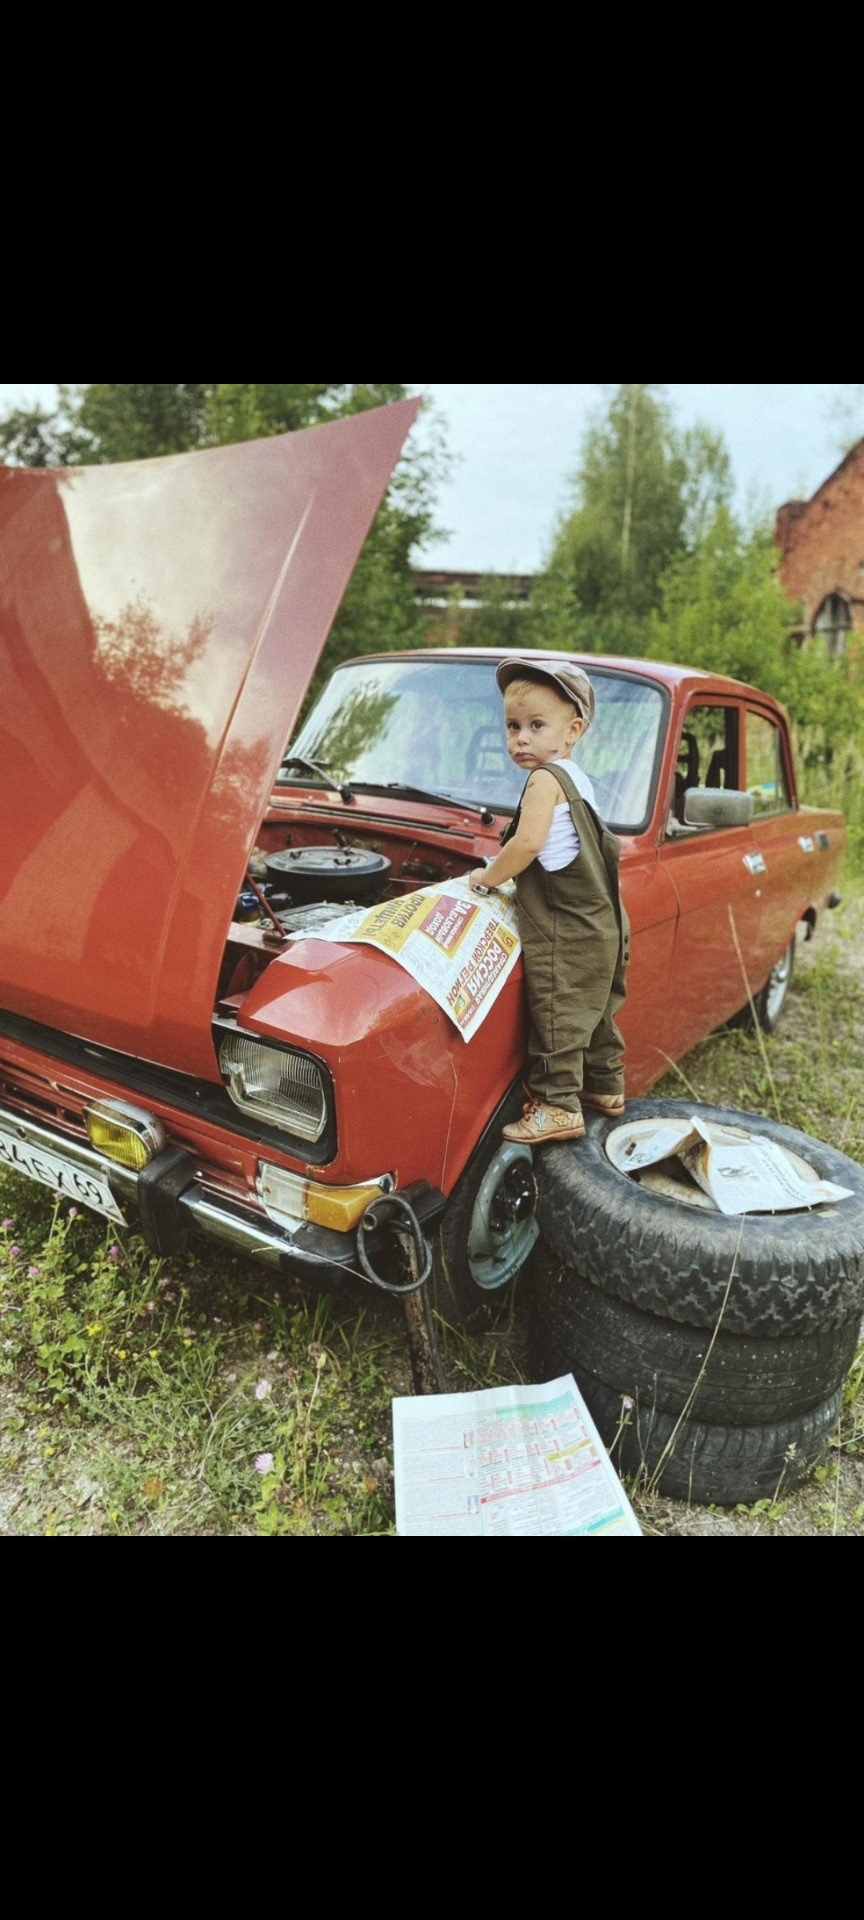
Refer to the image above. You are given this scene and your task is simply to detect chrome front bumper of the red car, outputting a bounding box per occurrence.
[0,1106,444,1290]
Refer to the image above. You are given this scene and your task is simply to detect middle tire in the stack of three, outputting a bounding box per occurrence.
[530,1274,860,1427]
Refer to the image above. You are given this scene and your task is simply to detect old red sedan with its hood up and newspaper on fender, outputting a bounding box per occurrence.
[0,401,845,1319]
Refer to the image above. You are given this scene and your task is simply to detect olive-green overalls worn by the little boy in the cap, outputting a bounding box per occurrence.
[503,766,630,1112]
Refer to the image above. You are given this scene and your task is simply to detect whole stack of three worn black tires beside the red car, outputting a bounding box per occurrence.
[530,1100,864,1505]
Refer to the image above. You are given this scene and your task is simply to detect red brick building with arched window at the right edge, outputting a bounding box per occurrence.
[774,440,864,659]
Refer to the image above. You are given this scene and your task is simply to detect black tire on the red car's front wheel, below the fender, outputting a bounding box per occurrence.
[428,1087,540,1327]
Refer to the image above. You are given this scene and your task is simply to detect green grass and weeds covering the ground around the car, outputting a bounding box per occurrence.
[0,893,864,1536]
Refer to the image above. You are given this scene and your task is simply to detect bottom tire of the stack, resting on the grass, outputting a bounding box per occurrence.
[526,1352,843,1507]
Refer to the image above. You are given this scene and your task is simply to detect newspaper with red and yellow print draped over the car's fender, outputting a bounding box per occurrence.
[290,879,520,1041]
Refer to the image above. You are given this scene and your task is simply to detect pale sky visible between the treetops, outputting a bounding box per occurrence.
[0,384,864,574]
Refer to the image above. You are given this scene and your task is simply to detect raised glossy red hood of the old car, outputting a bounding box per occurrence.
[0,399,420,1079]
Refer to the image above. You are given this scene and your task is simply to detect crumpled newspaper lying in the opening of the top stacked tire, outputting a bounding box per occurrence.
[607,1116,852,1213]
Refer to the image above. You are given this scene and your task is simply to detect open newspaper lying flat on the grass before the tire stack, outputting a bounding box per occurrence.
[394,1373,641,1538]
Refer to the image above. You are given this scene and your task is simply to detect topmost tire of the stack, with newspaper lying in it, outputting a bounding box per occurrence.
[538,1100,864,1340]
